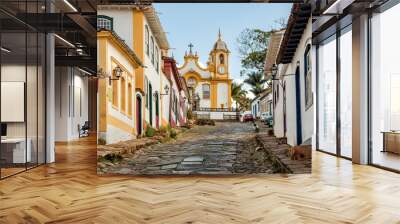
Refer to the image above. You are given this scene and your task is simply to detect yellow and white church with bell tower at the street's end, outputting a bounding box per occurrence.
[178,32,232,111]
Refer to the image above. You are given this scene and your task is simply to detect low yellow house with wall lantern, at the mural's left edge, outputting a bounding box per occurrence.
[97,26,143,144]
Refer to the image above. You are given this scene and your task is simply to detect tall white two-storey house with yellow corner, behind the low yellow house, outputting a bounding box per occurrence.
[97,5,169,135]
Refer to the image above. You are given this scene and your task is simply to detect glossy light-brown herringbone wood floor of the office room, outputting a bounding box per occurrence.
[0,136,400,224]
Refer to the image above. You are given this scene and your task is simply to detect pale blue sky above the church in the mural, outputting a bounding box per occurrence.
[154,3,292,97]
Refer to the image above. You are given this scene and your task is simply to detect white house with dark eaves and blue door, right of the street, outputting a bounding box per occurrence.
[267,4,314,145]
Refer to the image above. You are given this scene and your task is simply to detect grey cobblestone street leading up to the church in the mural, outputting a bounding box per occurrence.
[105,122,271,175]
